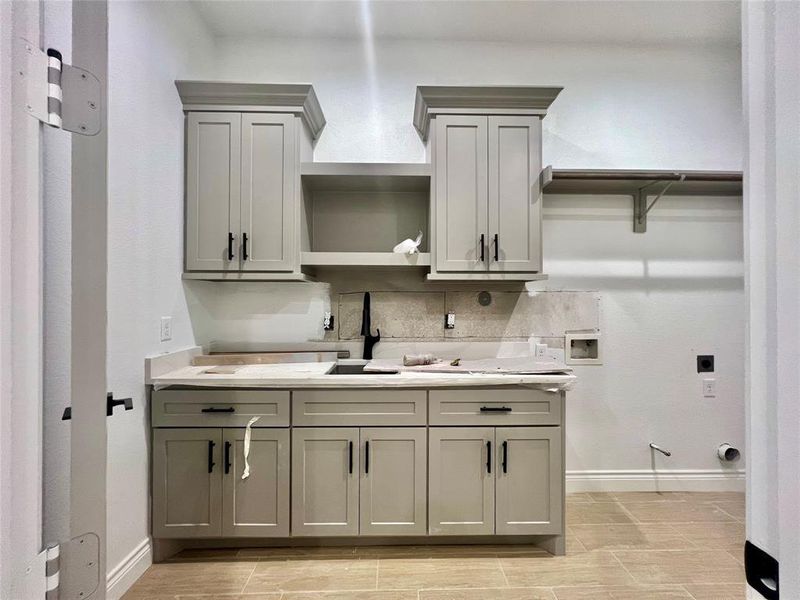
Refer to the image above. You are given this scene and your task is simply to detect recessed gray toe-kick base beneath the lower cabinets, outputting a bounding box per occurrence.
[153,535,566,562]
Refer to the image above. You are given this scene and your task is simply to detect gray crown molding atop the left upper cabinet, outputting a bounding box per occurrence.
[175,80,326,139]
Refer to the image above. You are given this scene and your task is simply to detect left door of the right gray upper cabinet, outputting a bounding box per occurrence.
[434,115,489,271]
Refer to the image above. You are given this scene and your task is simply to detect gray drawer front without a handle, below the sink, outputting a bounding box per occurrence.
[292,390,427,427]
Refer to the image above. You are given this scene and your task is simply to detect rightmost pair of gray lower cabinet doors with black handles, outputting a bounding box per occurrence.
[429,427,563,535]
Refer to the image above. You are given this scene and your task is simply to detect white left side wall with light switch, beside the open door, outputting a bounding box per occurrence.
[107,2,213,598]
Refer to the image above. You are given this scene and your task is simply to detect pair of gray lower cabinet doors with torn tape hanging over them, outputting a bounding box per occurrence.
[152,428,289,538]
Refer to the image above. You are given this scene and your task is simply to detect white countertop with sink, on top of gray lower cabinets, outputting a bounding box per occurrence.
[151,362,576,391]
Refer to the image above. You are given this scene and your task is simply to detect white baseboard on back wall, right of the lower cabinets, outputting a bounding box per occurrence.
[567,469,745,493]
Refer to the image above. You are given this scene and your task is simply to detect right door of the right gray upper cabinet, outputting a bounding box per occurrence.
[488,117,542,273]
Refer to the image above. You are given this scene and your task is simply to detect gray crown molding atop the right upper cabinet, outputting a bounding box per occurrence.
[414,85,564,140]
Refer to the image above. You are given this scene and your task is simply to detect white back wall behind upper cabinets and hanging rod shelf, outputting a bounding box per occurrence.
[186,38,744,489]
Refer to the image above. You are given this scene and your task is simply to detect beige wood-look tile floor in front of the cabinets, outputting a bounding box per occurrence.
[124,492,745,600]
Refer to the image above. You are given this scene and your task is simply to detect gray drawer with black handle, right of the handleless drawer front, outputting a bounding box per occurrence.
[430,388,561,425]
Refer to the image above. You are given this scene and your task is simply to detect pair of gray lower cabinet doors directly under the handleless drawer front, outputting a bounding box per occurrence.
[292,427,427,536]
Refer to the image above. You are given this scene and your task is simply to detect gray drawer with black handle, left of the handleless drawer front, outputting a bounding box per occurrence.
[152,390,289,427]
